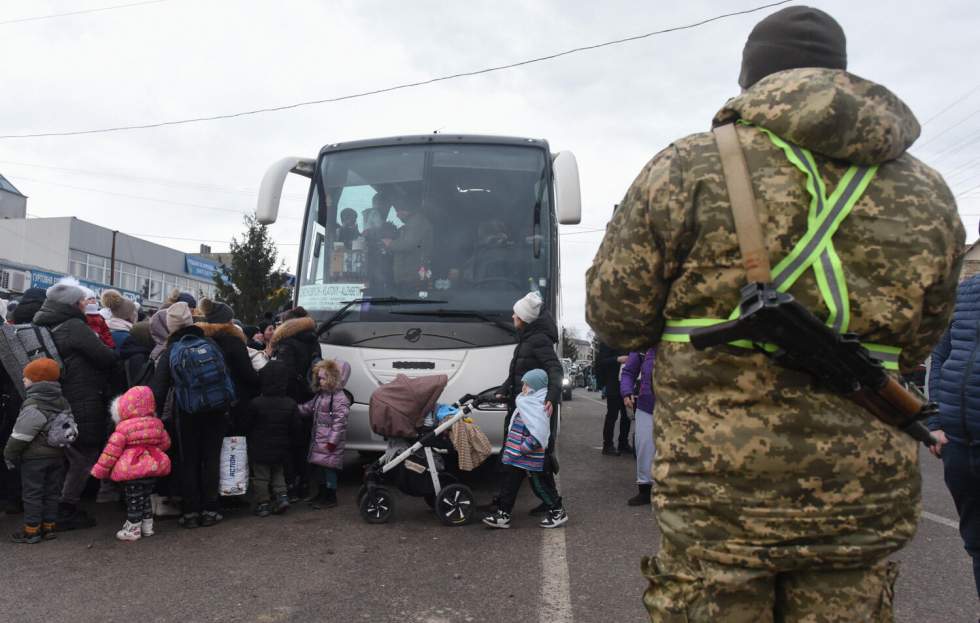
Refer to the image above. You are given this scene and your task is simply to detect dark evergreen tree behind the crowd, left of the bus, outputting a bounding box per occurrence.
[214,215,291,324]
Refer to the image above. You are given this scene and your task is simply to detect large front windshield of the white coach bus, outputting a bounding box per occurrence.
[298,144,554,322]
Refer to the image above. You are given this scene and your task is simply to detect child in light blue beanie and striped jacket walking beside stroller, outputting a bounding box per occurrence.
[483,368,568,528]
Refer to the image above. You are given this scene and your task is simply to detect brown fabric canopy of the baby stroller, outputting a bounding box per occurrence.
[369,374,449,437]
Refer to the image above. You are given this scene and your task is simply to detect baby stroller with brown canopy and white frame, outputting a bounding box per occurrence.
[358,375,476,526]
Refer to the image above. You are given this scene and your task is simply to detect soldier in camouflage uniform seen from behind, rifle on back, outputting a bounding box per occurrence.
[587,7,964,623]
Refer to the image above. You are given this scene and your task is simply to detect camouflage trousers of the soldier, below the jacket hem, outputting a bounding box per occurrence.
[643,541,898,623]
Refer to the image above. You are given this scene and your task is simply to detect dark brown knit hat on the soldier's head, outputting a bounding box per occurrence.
[738,6,847,89]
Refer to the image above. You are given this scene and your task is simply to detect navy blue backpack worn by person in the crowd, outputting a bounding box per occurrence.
[170,335,235,415]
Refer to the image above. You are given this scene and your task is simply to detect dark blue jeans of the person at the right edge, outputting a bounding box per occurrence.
[942,440,980,597]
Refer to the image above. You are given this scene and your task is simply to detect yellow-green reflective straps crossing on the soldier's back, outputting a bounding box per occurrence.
[661,122,901,370]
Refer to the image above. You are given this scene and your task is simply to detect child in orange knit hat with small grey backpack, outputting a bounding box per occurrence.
[3,358,77,544]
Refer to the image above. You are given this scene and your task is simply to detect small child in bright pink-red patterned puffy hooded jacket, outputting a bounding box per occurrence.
[92,386,170,541]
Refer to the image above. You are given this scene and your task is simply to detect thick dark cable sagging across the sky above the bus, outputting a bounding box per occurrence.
[0,0,790,139]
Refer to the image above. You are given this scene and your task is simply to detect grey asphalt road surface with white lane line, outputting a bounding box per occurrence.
[0,390,978,623]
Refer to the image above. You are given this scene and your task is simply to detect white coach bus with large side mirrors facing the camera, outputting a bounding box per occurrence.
[256,134,581,451]
